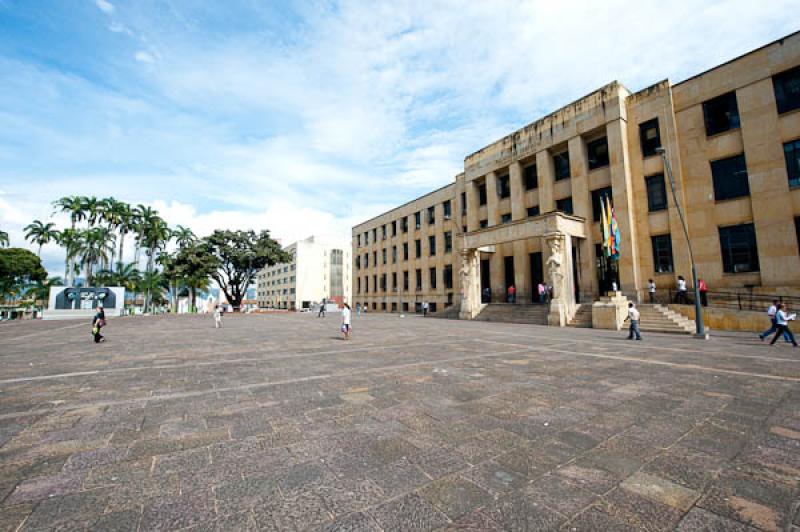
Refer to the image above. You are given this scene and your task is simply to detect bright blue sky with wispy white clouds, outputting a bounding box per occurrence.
[0,0,800,274]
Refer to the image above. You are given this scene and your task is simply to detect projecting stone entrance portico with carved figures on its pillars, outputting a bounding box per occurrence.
[459,212,586,326]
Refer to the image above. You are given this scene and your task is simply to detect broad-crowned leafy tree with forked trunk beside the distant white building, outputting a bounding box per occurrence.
[203,229,290,309]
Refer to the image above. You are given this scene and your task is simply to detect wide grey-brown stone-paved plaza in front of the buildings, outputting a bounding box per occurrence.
[0,314,800,531]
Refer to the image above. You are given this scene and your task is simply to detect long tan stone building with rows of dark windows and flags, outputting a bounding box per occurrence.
[352,33,800,324]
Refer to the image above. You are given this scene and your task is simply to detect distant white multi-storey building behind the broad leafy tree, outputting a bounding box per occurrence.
[256,236,352,310]
